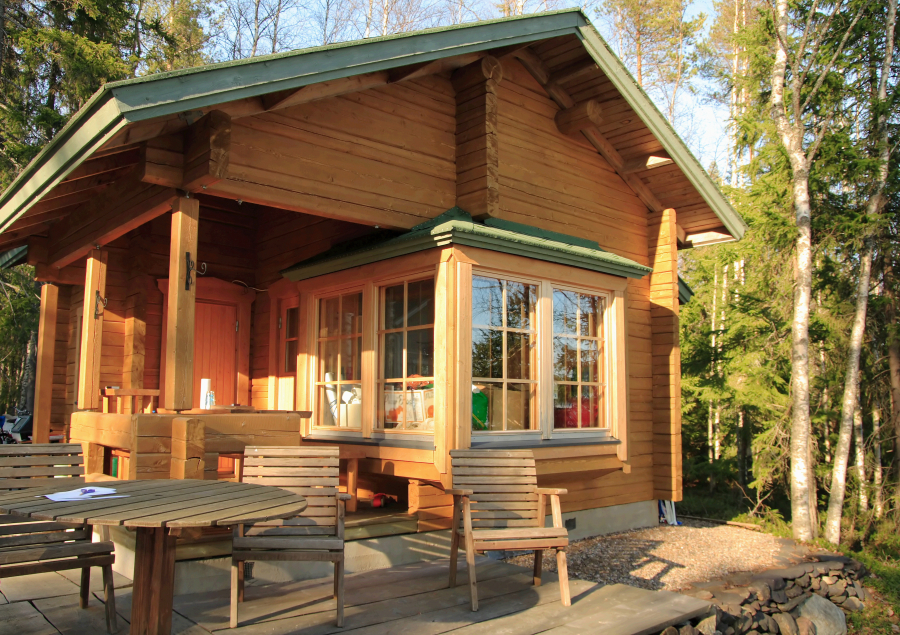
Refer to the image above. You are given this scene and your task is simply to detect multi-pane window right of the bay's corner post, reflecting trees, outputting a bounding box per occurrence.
[472,275,539,432]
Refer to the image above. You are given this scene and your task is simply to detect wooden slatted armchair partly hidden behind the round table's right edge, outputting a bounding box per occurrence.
[231,446,350,628]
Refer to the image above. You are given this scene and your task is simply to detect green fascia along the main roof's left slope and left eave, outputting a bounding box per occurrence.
[0,10,588,241]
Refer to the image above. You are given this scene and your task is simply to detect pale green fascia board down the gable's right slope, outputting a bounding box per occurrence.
[578,24,747,240]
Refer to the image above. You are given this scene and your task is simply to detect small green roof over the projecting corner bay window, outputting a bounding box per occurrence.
[281,207,651,282]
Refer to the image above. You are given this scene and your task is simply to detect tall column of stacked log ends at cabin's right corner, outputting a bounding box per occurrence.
[648,209,681,501]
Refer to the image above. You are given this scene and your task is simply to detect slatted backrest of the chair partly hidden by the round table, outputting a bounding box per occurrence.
[243,446,340,536]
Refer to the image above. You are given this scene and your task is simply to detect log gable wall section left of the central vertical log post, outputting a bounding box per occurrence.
[219,76,456,227]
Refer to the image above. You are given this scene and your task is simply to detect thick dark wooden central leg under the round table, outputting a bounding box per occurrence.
[131,527,175,635]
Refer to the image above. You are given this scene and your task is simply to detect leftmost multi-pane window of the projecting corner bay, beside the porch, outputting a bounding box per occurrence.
[316,292,363,428]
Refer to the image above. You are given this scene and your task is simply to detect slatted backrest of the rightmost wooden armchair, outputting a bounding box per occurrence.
[450,450,543,529]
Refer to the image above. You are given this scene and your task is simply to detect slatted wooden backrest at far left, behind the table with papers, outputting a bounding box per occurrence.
[0,443,84,492]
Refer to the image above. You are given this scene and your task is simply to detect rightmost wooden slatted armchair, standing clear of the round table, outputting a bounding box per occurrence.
[447,450,572,611]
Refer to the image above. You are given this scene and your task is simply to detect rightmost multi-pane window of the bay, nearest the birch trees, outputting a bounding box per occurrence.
[552,289,606,429]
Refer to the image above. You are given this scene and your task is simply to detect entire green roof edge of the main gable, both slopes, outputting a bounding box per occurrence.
[0,9,746,243]
